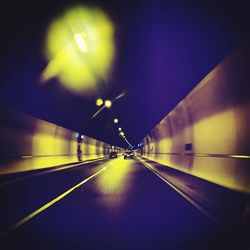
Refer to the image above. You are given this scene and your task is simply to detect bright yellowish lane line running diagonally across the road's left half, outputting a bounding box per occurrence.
[0,165,109,238]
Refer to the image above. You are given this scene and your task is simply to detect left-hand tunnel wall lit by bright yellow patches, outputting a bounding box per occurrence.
[0,107,109,174]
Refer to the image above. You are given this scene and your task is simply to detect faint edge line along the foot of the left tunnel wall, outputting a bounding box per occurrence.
[0,158,106,187]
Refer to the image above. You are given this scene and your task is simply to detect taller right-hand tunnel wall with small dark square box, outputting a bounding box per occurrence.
[142,41,250,192]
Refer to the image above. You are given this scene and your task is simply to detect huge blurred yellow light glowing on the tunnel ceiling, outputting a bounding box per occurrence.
[42,6,115,94]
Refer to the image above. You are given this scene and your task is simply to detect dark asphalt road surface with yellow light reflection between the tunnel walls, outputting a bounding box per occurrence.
[0,157,245,250]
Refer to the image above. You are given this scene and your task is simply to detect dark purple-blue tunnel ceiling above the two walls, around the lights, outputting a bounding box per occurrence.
[0,0,250,147]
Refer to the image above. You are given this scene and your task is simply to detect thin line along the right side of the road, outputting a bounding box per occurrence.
[137,158,221,225]
